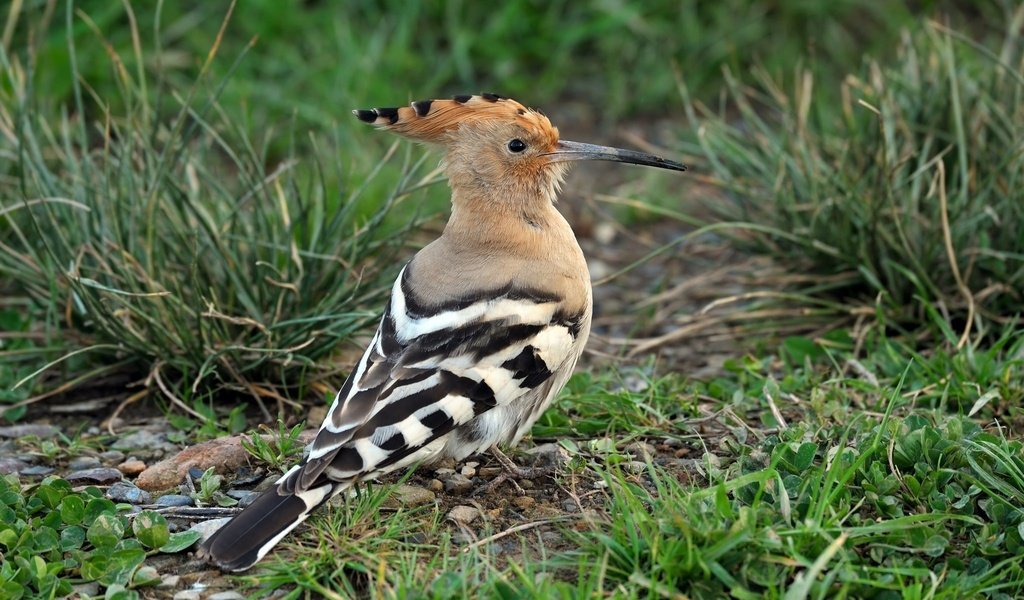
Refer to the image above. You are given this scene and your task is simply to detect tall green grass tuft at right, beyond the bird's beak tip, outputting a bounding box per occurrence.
[688,5,1024,347]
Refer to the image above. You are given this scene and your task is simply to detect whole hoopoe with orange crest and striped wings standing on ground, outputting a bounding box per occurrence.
[199,93,686,571]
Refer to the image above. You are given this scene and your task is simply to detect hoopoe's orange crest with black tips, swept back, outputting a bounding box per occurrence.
[352,93,558,146]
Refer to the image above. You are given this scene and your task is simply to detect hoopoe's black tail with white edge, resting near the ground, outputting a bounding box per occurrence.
[199,465,346,571]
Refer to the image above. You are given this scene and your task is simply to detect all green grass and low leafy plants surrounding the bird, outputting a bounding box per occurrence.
[0,0,1024,599]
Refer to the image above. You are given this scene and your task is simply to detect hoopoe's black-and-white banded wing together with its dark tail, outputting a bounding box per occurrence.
[200,266,590,571]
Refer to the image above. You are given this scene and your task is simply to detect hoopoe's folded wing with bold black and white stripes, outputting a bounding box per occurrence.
[293,269,584,491]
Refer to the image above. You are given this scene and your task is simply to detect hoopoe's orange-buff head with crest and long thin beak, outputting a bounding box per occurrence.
[352,93,686,200]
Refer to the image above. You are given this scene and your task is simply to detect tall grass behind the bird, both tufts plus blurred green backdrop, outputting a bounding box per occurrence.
[0,0,1024,418]
